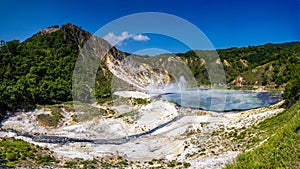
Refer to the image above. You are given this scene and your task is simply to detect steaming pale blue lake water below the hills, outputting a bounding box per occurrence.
[162,89,282,112]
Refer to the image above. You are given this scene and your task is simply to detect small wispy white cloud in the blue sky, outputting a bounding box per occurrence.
[103,31,150,46]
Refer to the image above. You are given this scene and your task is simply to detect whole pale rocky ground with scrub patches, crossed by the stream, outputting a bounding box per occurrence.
[0,92,284,168]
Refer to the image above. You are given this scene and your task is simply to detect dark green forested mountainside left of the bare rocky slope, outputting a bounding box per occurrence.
[0,24,91,113]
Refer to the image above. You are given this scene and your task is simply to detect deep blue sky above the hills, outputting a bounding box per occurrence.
[0,0,300,53]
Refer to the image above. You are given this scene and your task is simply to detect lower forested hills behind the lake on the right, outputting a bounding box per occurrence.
[178,42,300,87]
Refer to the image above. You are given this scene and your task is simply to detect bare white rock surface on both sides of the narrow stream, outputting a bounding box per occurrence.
[0,100,284,168]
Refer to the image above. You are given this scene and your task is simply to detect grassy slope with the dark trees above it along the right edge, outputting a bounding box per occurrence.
[226,42,300,169]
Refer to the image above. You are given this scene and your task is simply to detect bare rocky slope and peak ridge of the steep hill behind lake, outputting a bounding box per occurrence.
[36,24,192,91]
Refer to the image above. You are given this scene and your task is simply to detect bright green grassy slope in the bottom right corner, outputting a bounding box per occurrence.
[226,101,300,169]
